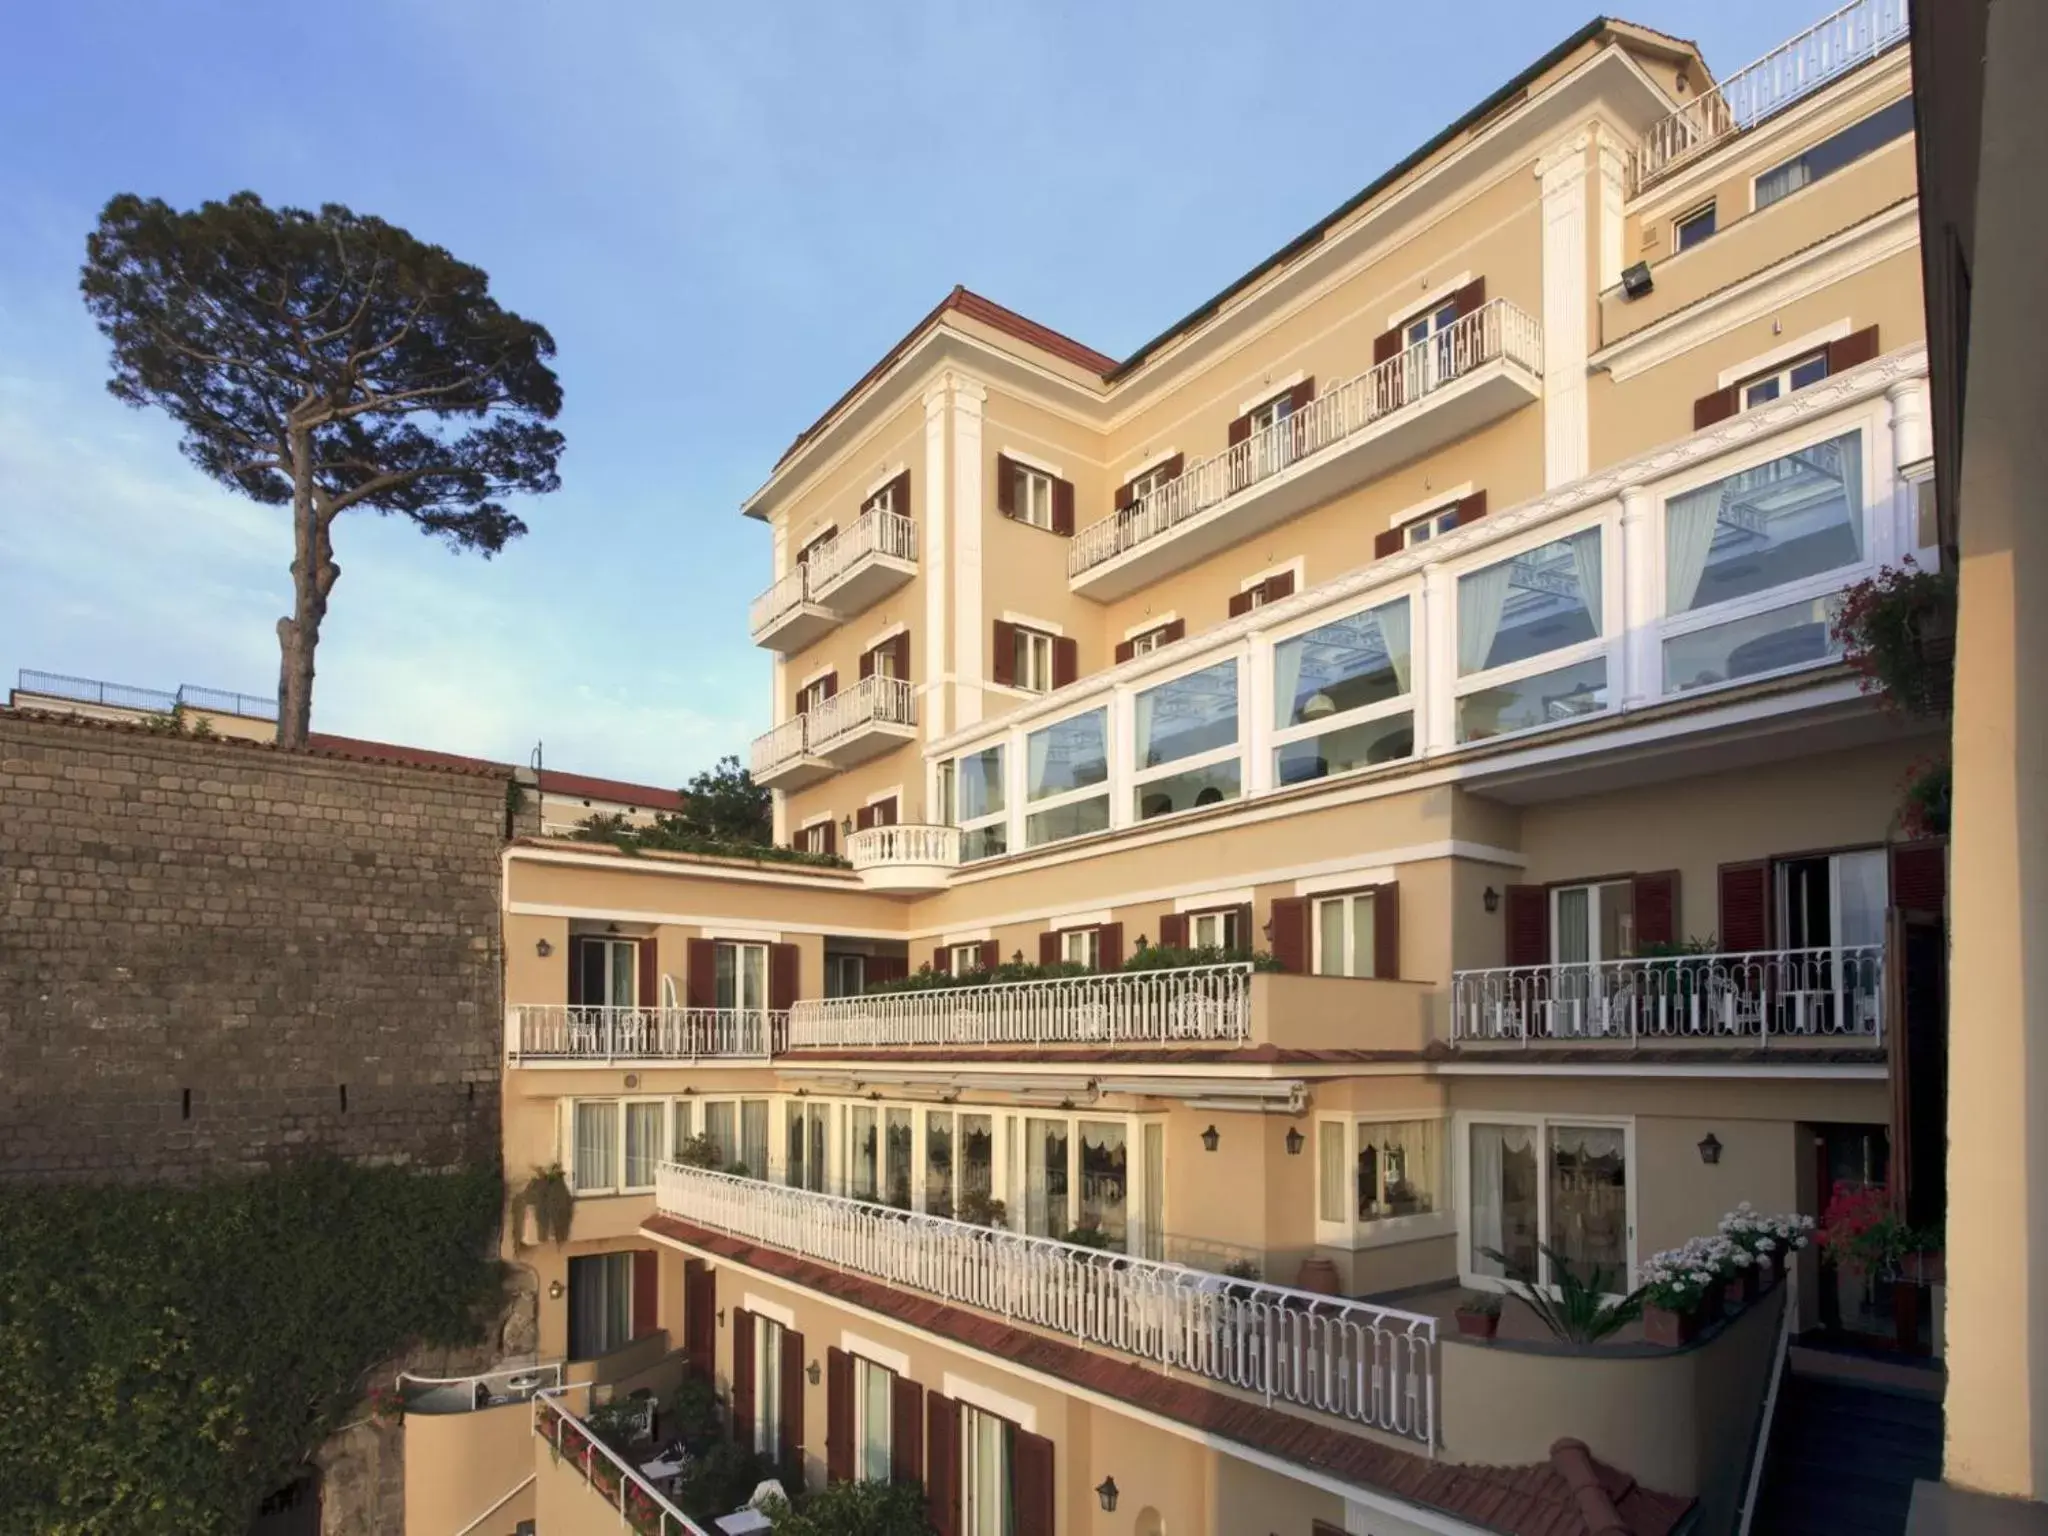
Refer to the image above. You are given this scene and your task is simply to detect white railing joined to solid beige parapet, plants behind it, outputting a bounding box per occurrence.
[788,965,1251,1049]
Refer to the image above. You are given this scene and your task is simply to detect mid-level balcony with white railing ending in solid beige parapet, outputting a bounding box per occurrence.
[788,965,1430,1057]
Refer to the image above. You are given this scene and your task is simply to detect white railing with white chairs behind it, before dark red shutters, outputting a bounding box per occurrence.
[1450,944,1884,1047]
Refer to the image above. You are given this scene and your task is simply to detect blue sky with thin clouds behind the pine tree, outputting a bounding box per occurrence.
[0,0,1825,784]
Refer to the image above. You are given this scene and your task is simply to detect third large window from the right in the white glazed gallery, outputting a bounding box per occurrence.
[1274,598,1415,784]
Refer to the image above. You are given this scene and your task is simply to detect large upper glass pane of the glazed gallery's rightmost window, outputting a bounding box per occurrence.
[1665,432,1864,612]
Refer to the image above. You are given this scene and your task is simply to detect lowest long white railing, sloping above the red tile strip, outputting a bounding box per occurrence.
[655,1163,1436,1444]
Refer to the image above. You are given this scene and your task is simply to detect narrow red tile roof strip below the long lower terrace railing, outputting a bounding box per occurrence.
[641,1214,1694,1536]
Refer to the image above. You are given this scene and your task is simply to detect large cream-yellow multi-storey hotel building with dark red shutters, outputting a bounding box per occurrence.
[408,0,1946,1536]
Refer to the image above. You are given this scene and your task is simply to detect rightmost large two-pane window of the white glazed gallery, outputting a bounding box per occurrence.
[1663,432,1866,692]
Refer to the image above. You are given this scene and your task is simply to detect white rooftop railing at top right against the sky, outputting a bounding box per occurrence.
[1630,0,1909,193]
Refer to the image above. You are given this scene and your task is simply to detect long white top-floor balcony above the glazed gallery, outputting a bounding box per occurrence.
[1067,299,1542,602]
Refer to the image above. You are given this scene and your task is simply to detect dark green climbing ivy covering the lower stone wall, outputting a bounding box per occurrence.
[0,1157,504,1536]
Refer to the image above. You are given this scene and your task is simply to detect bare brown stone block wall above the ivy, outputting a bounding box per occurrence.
[0,711,506,1180]
